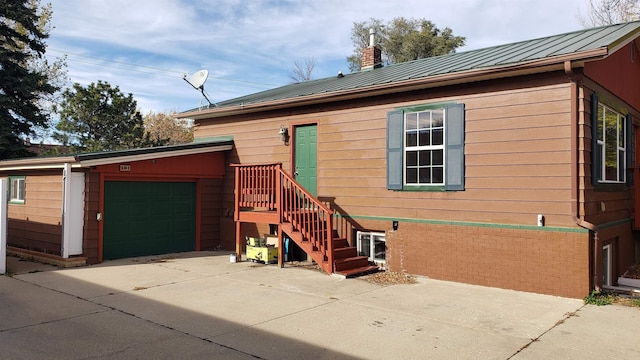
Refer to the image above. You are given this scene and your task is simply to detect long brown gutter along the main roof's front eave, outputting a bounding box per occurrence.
[176,48,609,120]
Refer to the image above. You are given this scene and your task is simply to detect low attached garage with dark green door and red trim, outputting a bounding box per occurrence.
[0,138,233,266]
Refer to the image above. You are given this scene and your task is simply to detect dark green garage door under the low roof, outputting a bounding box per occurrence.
[103,181,196,260]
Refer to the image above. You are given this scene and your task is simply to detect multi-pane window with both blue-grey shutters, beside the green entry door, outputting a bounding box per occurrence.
[387,104,464,190]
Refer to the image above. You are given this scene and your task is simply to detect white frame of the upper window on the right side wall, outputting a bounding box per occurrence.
[597,103,628,184]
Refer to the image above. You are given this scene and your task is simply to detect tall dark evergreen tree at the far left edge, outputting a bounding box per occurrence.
[0,0,57,159]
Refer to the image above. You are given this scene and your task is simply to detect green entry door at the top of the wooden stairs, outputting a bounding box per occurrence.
[294,125,318,196]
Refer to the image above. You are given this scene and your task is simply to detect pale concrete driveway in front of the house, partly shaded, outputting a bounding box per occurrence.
[0,252,640,359]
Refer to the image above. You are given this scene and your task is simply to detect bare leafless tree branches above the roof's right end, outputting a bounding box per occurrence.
[578,0,640,28]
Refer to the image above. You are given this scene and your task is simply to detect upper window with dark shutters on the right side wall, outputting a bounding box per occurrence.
[591,94,633,185]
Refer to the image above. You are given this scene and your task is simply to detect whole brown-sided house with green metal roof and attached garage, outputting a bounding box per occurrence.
[0,22,640,298]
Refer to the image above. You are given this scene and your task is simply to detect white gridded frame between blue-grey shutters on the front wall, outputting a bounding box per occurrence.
[402,108,447,187]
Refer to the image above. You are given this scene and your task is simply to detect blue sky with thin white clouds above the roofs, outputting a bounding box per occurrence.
[43,0,586,114]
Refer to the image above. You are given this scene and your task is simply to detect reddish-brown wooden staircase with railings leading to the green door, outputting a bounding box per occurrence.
[234,164,378,277]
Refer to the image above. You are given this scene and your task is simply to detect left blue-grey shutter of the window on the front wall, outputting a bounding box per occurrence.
[387,110,404,190]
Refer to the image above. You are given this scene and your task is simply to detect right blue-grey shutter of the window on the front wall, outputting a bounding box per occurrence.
[444,104,464,190]
